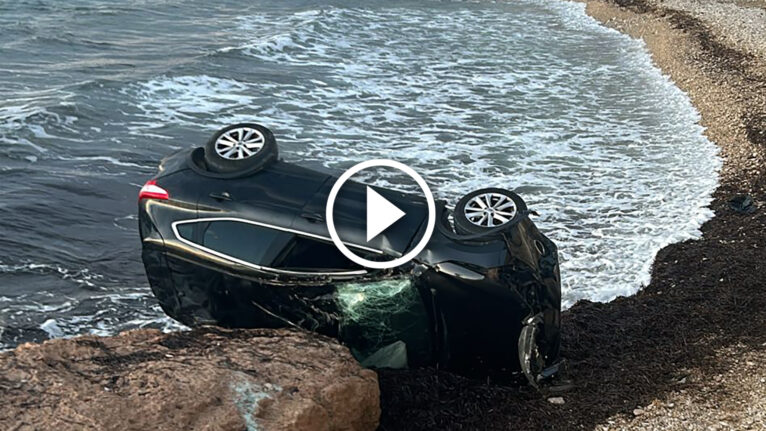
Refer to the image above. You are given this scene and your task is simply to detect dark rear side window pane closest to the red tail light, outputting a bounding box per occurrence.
[177,220,295,266]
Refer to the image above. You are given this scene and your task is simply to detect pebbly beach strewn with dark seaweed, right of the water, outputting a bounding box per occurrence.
[380,0,766,430]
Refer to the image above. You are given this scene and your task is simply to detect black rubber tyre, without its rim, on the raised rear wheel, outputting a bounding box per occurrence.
[205,123,279,174]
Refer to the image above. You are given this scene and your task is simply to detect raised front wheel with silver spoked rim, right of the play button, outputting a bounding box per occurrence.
[453,188,527,235]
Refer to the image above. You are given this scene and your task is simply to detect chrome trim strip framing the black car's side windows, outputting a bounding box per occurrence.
[171,217,383,276]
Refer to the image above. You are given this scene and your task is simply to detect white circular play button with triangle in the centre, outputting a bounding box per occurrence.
[325,159,436,269]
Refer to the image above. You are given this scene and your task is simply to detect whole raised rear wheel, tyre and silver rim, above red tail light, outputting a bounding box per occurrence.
[205,123,277,174]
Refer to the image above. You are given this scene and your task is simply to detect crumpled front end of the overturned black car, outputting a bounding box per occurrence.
[419,217,561,384]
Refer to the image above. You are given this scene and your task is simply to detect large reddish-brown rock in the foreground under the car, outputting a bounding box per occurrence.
[0,328,380,431]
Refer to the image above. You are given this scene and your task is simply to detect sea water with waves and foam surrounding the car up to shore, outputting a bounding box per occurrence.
[0,0,720,347]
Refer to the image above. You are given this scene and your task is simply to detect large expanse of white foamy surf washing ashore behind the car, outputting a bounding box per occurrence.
[125,0,720,306]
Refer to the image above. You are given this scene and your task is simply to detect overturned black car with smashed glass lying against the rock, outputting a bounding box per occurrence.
[139,124,561,384]
